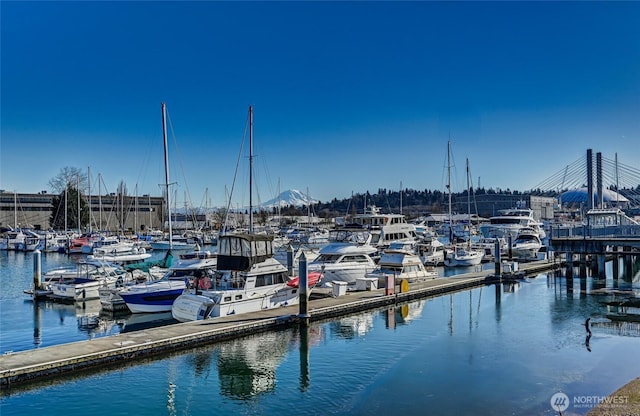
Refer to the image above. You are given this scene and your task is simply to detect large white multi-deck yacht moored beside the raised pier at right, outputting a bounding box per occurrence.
[480,208,546,240]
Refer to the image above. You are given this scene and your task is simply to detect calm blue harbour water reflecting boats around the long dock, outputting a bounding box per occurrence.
[0,252,640,416]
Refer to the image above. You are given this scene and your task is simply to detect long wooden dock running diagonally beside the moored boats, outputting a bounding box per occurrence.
[0,260,559,389]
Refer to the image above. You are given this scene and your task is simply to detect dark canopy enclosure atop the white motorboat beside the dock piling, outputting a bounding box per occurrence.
[217,234,273,271]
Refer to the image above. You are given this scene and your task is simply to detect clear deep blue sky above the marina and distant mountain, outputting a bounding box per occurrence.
[0,1,640,206]
